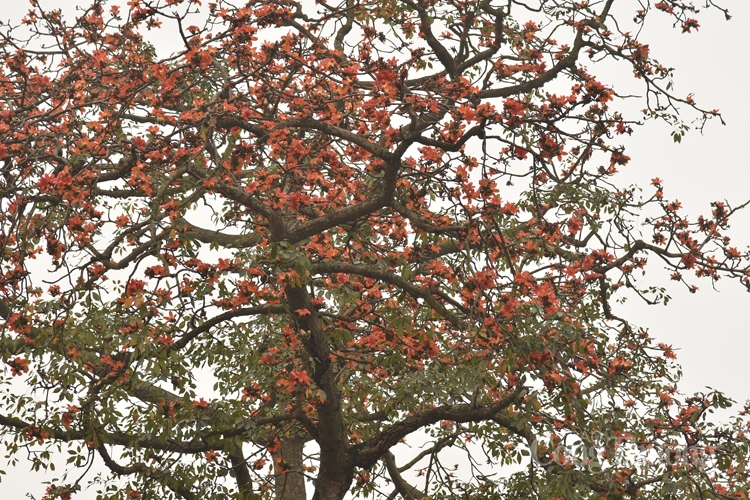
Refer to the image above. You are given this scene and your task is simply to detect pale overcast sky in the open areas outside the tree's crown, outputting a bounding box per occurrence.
[0,0,750,500]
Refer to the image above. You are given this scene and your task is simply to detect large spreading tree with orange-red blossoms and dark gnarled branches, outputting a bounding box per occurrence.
[0,0,750,500]
